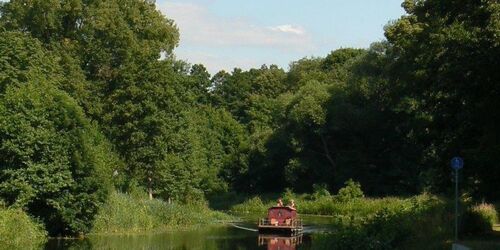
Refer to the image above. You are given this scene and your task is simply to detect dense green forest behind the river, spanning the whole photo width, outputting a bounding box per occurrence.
[0,0,500,236]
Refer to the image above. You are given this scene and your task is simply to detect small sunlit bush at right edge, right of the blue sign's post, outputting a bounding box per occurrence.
[462,203,498,234]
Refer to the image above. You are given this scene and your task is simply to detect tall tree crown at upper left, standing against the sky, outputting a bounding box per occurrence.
[0,0,179,120]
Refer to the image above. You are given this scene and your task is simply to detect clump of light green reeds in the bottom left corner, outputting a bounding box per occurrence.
[0,208,47,249]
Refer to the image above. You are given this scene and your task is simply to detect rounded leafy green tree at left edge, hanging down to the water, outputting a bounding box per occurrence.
[0,81,112,234]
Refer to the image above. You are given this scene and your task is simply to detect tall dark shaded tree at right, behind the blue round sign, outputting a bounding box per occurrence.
[385,0,500,199]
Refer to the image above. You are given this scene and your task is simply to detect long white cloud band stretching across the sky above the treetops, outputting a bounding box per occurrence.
[158,2,314,53]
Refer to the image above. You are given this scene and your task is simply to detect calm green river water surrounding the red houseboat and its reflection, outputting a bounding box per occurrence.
[46,217,338,250]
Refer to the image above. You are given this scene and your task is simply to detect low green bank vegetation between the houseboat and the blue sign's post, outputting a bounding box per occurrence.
[231,193,453,249]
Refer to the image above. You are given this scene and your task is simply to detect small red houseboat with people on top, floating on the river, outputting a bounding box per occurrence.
[259,207,303,234]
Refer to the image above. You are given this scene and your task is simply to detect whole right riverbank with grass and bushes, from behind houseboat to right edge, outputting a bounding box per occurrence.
[224,182,500,249]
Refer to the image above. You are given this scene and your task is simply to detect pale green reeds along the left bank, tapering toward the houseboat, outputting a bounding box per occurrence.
[91,192,231,234]
